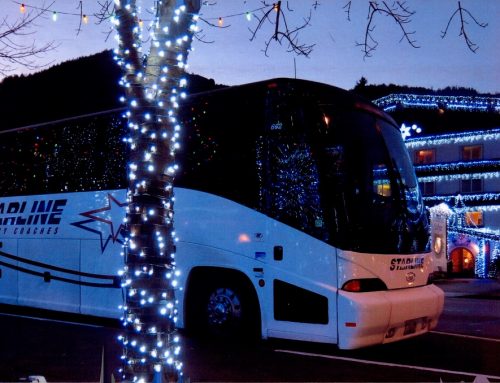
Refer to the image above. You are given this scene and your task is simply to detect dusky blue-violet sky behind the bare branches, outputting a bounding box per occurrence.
[0,0,500,93]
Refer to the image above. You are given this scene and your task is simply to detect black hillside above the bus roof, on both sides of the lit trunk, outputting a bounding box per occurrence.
[0,51,224,130]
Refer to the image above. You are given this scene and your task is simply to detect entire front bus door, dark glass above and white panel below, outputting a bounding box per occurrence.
[256,91,337,342]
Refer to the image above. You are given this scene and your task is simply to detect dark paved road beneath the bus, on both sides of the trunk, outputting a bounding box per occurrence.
[0,281,500,382]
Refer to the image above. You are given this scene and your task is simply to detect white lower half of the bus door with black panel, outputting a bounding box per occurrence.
[263,222,337,343]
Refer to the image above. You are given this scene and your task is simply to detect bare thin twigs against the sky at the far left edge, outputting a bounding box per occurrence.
[0,4,57,76]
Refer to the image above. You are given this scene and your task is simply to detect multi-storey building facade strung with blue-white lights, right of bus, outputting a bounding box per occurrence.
[375,95,500,278]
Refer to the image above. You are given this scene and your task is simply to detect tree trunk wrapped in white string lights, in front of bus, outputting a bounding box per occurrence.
[113,0,200,382]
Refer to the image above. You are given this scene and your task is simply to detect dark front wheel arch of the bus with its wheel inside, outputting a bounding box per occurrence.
[184,266,261,339]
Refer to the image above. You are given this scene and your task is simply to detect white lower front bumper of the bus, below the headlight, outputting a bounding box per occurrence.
[337,285,444,349]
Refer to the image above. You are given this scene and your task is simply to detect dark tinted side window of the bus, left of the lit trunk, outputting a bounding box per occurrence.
[0,113,127,196]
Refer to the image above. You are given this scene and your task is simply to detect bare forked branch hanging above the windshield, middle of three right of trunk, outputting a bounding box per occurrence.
[356,1,419,58]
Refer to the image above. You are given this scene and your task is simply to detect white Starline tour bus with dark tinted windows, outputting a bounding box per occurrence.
[0,79,444,349]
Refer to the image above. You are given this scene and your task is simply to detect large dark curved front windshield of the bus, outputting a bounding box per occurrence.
[319,109,428,254]
